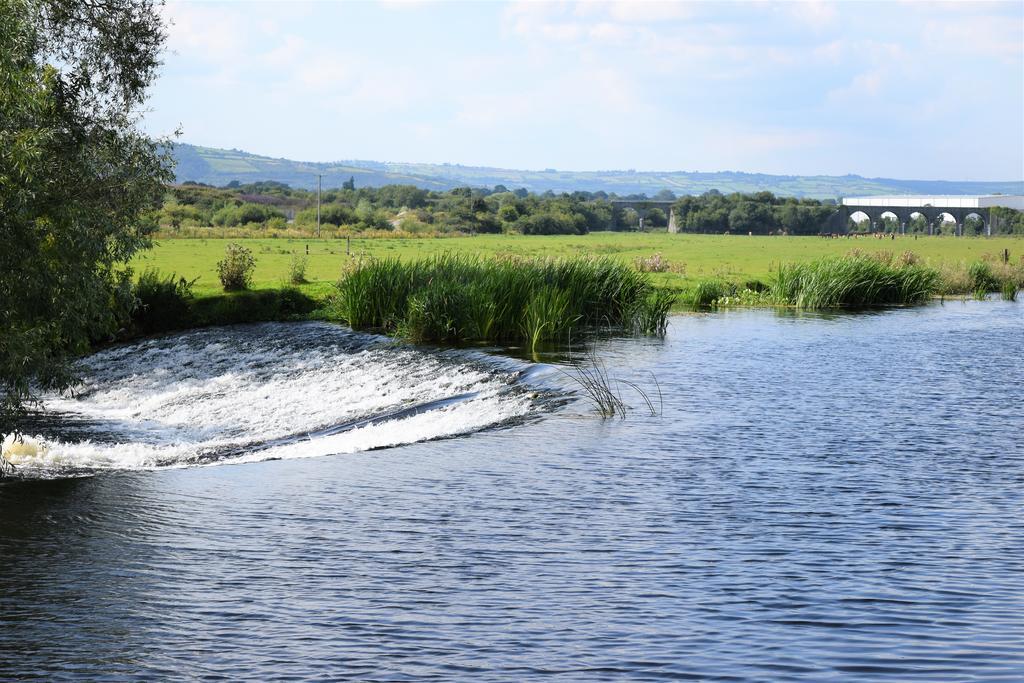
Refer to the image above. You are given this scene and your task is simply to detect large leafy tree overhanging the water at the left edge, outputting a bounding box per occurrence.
[0,0,173,454]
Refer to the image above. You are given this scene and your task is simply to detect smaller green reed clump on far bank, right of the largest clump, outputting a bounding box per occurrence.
[772,254,939,308]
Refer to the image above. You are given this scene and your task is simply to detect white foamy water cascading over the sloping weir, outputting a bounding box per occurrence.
[3,323,535,474]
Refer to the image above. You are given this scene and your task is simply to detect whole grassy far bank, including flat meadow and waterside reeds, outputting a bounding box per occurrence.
[135,233,1024,339]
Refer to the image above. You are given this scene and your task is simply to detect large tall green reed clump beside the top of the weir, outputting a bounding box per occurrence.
[334,254,674,348]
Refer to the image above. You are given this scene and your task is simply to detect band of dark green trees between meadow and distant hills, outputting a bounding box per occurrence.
[150,181,1024,236]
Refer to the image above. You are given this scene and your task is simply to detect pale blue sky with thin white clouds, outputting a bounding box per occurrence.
[143,0,1024,180]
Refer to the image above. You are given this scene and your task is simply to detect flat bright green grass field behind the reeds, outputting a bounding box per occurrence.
[132,232,1024,296]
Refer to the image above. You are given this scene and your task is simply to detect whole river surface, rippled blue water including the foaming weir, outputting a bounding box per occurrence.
[0,301,1024,681]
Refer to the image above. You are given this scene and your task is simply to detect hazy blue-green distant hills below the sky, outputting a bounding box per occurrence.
[174,143,1024,199]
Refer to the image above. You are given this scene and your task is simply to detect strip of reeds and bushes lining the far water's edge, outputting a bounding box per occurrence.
[117,242,1024,349]
